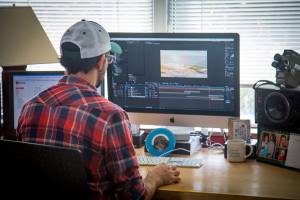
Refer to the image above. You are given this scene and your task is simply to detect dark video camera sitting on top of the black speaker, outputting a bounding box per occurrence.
[272,50,300,88]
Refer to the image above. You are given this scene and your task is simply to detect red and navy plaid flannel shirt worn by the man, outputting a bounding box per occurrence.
[17,76,146,200]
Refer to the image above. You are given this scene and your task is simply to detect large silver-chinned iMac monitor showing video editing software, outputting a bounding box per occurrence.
[108,33,240,128]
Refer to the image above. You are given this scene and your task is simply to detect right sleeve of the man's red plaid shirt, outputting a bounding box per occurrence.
[105,111,146,199]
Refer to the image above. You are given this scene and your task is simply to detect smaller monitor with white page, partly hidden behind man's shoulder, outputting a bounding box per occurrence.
[8,71,104,133]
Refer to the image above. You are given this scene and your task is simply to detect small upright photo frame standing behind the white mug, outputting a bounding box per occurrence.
[228,118,251,143]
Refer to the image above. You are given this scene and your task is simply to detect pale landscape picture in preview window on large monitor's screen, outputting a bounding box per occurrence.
[160,50,207,78]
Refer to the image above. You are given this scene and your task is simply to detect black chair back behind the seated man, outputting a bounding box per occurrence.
[0,140,89,200]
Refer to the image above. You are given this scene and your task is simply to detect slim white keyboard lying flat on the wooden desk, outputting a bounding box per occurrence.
[137,156,203,168]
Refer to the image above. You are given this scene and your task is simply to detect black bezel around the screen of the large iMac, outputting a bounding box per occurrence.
[107,33,240,127]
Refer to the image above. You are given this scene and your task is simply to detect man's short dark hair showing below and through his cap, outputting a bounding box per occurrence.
[60,42,101,74]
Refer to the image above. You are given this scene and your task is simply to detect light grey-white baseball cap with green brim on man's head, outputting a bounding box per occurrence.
[60,20,122,59]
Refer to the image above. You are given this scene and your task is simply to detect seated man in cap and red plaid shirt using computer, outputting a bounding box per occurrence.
[17,20,180,199]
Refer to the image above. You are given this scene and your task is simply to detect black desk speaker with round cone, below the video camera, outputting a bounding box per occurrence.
[255,85,300,132]
